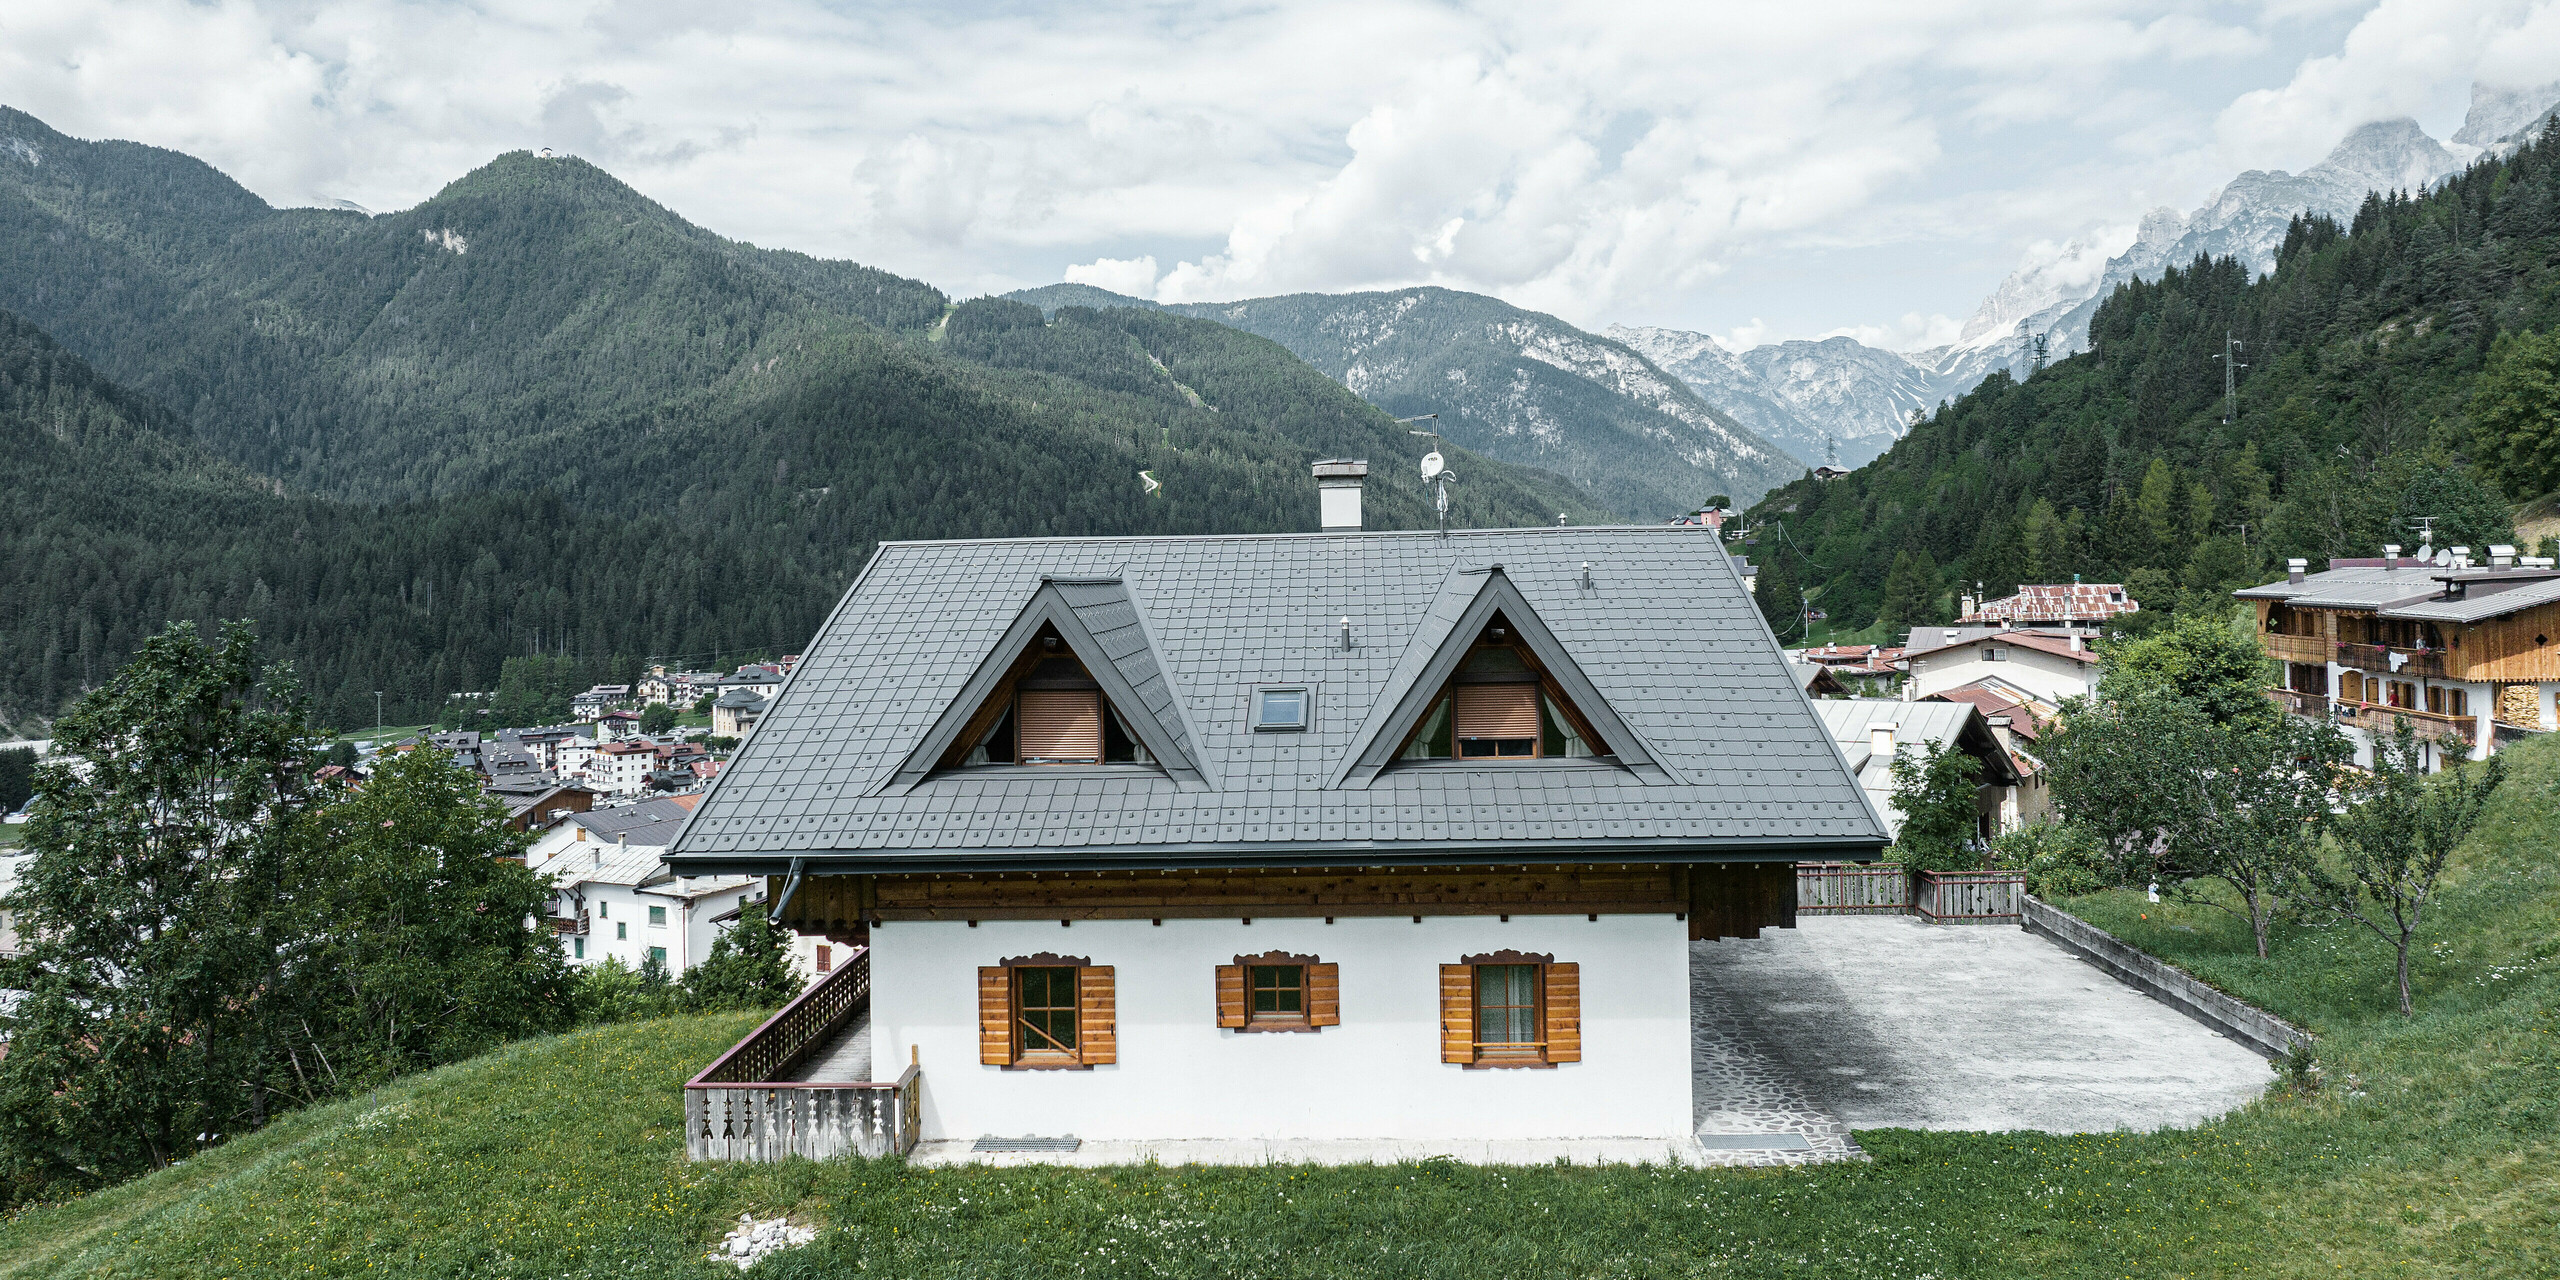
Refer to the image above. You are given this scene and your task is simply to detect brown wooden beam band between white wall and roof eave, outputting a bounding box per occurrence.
[849,863,1687,932]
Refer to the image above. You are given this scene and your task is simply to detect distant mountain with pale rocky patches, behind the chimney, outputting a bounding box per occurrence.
[1006,284,1805,517]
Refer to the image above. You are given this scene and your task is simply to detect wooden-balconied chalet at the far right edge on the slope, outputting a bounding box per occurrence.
[2235,545,2560,763]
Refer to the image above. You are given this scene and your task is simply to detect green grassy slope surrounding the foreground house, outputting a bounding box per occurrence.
[0,740,2560,1280]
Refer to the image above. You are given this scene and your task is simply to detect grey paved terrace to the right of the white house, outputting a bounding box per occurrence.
[1690,916,2273,1144]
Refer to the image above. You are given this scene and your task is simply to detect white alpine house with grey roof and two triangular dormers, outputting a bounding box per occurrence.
[668,463,1887,1142]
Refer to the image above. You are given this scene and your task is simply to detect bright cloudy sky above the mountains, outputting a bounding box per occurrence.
[15,0,2560,348]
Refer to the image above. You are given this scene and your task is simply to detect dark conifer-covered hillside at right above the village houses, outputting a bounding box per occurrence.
[1751,122,2560,637]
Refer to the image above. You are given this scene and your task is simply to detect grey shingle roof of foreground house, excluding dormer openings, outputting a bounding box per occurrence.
[671,527,1884,876]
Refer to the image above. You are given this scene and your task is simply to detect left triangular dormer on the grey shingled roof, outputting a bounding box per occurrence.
[878,576,1211,796]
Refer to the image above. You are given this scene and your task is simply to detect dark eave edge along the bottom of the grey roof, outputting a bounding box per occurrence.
[666,832,1889,876]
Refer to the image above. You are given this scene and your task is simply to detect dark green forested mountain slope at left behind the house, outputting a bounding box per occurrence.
[0,113,1610,724]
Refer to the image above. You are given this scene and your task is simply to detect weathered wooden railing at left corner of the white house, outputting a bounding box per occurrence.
[684,947,924,1162]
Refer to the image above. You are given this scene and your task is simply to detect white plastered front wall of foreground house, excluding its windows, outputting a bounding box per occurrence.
[870,914,1692,1139]
